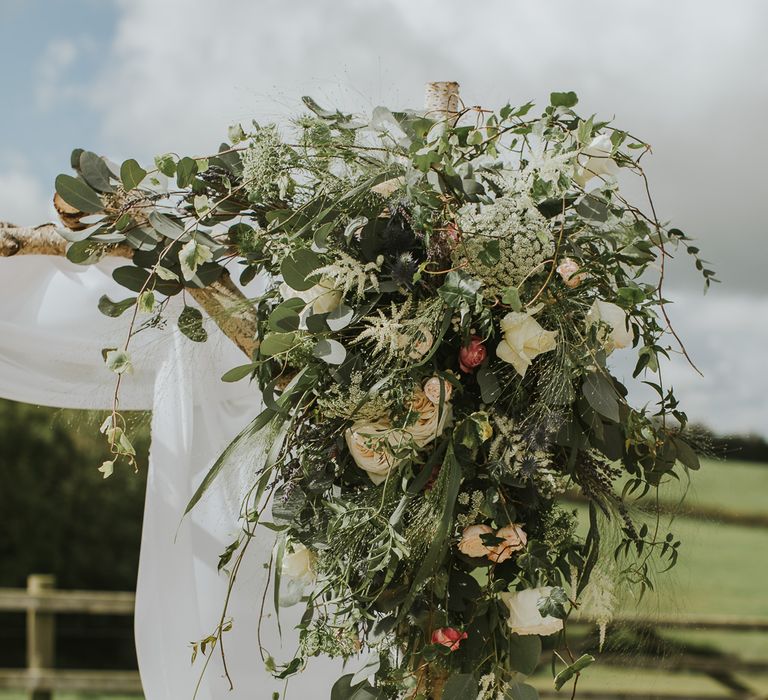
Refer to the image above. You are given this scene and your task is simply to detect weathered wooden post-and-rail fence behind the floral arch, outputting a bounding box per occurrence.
[0,575,768,700]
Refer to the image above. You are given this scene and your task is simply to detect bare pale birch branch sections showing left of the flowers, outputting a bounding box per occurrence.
[0,221,258,359]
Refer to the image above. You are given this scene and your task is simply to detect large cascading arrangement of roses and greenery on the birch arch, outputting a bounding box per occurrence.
[52,93,714,700]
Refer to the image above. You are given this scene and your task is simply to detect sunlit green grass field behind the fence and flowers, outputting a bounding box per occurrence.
[0,461,768,700]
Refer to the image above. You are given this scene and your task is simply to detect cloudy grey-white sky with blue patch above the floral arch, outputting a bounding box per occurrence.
[0,0,768,435]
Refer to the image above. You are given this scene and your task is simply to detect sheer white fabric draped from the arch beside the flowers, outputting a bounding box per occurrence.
[0,256,339,700]
